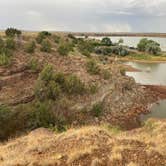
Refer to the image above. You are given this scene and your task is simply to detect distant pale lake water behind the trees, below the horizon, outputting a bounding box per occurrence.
[89,36,166,51]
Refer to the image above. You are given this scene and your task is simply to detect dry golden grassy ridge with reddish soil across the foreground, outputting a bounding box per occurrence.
[0,120,166,166]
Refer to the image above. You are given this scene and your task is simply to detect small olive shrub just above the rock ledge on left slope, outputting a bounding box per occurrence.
[27,58,40,72]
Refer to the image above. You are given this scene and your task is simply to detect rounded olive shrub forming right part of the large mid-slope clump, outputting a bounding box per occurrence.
[64,75,85,94]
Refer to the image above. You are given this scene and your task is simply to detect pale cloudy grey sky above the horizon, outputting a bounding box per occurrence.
[0,0,166,32]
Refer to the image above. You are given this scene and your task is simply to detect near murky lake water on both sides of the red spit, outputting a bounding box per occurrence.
[125,62,166,121]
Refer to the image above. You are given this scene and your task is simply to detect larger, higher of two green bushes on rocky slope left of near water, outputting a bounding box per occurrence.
[86,60,100,74]
